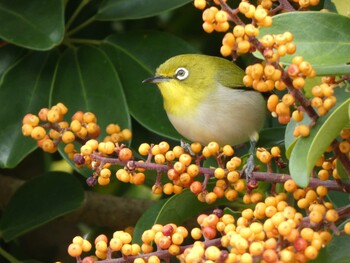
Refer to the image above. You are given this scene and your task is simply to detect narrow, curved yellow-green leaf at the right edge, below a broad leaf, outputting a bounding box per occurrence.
[289,91,350,187]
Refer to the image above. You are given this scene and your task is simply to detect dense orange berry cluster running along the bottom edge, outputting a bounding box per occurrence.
[68,201,350,263]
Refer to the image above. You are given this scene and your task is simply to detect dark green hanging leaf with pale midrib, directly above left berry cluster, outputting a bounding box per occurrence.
[51,46,131,175]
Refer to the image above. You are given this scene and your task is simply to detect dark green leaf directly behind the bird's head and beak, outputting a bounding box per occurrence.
[101,32,198,140]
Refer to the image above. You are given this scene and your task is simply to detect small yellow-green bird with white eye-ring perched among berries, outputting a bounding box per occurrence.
[144,54,266,146]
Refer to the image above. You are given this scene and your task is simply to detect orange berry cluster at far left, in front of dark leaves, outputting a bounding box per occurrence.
[22,103,131,161]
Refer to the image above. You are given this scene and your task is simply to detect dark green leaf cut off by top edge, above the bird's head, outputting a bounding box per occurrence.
[96,0,192,20]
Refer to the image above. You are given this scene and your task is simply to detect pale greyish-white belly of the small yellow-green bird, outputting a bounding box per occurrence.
[168,87,266,146]
